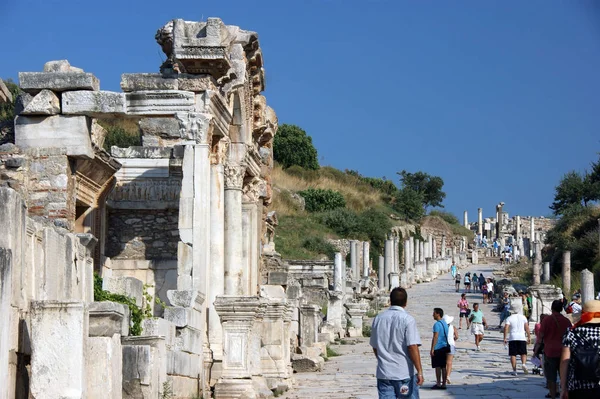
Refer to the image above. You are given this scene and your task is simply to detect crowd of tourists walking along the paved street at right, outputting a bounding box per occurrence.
[370,265,600,399]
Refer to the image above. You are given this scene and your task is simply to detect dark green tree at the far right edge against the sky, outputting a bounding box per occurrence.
[550,171,591,215]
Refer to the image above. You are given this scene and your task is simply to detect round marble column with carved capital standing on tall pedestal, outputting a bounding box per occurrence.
[224,163,247,295]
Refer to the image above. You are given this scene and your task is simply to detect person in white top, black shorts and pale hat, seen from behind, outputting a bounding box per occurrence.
[504,302,531,375]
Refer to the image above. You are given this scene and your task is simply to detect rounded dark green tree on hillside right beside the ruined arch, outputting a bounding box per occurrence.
[273,124,319,170]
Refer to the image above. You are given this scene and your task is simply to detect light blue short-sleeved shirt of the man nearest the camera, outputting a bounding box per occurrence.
[370,306,421,381]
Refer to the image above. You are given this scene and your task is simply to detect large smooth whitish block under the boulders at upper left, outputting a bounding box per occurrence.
[15,115,94,159]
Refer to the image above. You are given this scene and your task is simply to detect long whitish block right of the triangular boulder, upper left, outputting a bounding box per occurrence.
[62,91,125,117]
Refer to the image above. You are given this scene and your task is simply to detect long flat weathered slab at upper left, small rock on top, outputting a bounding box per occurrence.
[19,72,100,93]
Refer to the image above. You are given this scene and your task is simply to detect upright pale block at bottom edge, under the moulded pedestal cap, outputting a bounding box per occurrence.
[85,334,123,399]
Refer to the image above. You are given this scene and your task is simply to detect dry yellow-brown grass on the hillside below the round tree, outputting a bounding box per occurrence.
[272,165,382,215]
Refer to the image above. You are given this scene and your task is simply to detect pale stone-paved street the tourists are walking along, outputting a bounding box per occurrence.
[283,265,547,399]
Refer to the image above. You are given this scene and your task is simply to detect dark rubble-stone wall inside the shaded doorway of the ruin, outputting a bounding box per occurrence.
[106,209,179,259]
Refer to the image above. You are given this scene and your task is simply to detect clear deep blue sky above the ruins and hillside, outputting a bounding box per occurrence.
[0,0,600,221]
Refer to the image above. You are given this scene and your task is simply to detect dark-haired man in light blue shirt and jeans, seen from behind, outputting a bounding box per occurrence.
[370,287,423,399]
